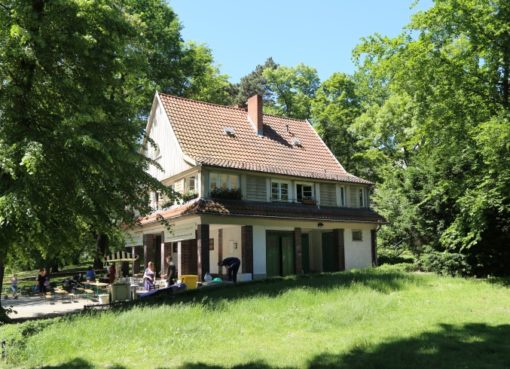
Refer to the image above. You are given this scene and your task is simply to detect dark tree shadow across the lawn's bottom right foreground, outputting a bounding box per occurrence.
[171,324,510,369]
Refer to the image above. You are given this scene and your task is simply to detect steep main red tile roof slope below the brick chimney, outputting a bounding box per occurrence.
[159,93,371,184]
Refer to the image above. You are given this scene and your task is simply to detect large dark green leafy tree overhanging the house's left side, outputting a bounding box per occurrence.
[0,0,223,318]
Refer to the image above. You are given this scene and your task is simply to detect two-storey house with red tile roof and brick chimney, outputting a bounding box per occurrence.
[126,93,384,279]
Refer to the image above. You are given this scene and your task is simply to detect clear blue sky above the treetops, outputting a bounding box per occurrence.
[169,0,432,82]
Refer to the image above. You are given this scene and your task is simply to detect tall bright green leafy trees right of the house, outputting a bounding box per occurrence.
[353,0,510,275]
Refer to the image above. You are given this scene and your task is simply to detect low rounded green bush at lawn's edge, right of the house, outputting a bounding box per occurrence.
[418,251,473,276]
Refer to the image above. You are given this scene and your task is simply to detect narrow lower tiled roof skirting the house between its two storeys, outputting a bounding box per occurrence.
[140,199,386,225]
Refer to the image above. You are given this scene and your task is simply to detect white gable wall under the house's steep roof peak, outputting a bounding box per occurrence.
[147,96,192,181]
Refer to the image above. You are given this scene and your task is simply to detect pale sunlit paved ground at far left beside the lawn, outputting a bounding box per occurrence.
[2,296,99,319]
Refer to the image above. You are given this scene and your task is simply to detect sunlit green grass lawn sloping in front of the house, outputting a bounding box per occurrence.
[0,270,510,369]
